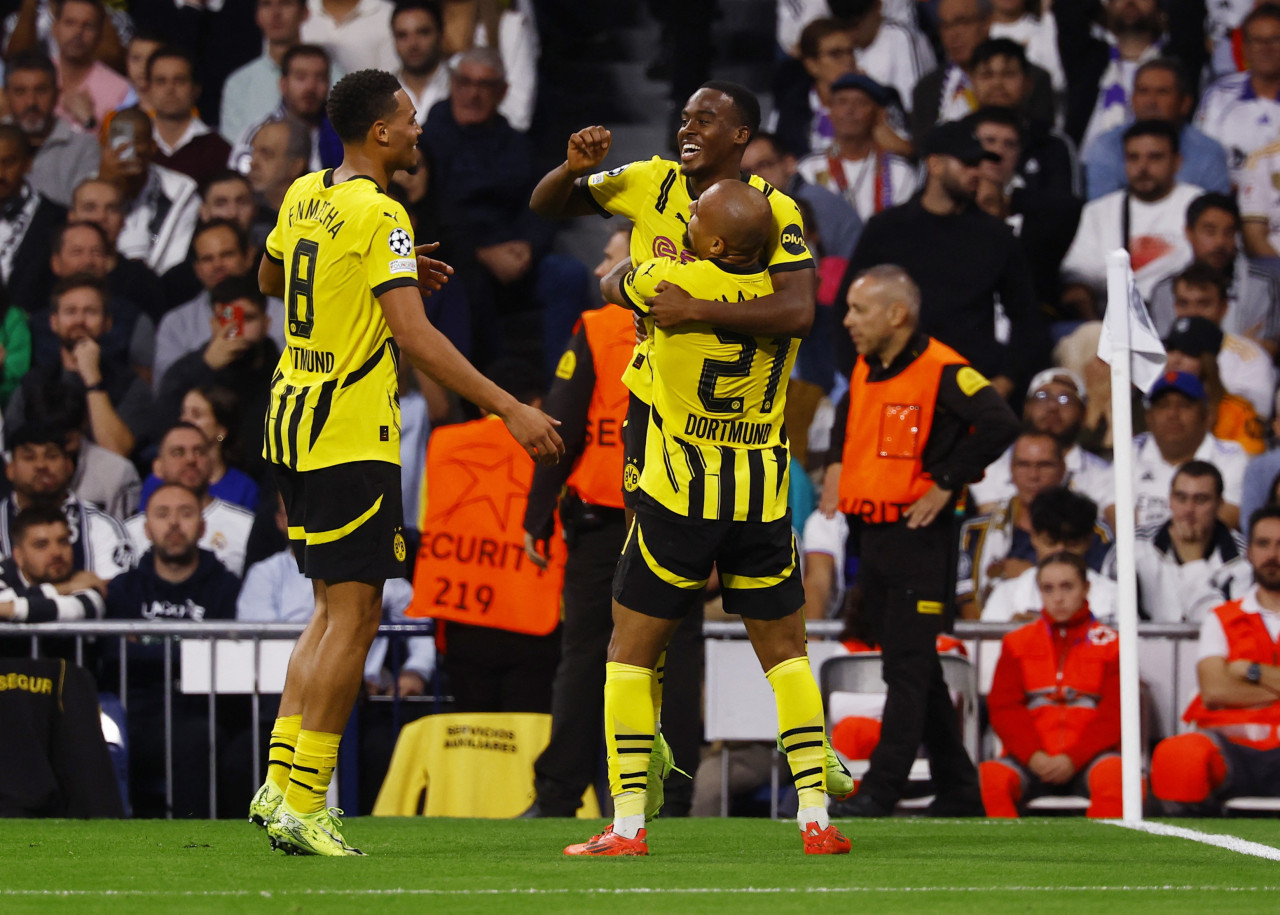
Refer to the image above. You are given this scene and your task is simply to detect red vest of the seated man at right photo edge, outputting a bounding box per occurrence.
[1183,599,1280,750]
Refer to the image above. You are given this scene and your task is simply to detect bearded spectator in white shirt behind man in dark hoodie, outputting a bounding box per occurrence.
[124,422,253,577]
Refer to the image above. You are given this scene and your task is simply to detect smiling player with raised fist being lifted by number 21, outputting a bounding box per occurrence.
[530,81,854,816]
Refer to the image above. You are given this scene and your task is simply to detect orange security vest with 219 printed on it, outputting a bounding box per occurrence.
[406,416,564,636]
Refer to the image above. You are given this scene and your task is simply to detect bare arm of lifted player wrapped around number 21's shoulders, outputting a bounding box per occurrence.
[649,267,818,337]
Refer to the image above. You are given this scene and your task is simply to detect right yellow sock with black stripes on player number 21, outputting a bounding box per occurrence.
[764,656,827,810]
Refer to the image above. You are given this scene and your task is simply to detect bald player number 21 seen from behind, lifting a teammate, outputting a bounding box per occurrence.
[564,180,850,856]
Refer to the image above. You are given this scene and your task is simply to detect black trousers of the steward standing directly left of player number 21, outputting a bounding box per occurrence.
[534,511,627,816]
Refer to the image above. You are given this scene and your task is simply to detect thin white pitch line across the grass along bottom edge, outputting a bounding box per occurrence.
[0,884,1280,897]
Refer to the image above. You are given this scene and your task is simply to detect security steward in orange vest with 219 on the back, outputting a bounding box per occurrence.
[406,358,564,714]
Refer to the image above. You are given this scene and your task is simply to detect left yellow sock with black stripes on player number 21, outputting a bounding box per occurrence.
[604,662,655,824]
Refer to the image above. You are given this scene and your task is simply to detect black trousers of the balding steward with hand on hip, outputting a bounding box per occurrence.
[858,511,978,806]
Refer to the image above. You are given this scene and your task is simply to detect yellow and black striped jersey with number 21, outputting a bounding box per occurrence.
[622,259,799,521]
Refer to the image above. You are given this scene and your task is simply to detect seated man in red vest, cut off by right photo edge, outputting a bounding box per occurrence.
[1151,505,1280,816]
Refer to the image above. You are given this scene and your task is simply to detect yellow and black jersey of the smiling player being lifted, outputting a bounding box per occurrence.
[586,156,814,402]
